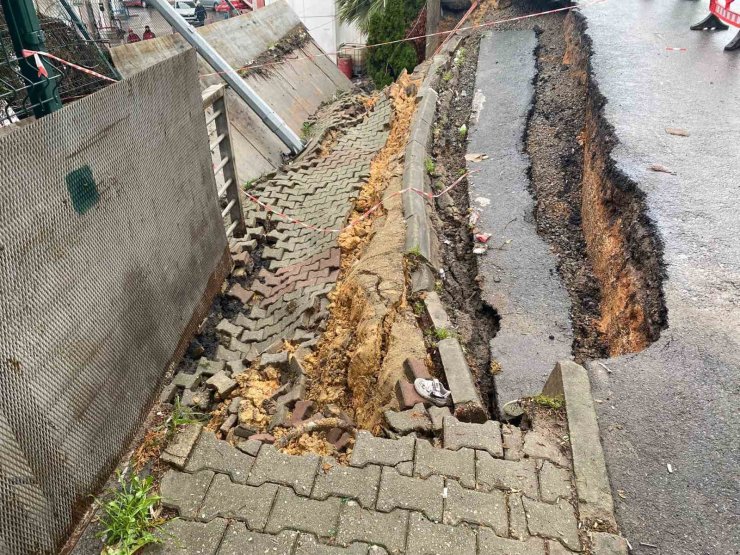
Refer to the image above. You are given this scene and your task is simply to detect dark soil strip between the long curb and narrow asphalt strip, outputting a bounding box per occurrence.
[427,36,499,414]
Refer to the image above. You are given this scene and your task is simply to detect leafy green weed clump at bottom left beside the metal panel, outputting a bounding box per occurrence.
[96,476,164,555]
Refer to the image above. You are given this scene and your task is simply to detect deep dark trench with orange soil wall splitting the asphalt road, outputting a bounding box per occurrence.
[525,7,667,362]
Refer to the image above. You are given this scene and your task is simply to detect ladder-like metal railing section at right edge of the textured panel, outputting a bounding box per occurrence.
[202,85,246,238]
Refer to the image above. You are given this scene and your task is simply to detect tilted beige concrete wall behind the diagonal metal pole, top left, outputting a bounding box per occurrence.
[111,0,351,185]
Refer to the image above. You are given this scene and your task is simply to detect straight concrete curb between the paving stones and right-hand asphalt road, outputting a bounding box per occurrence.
[542,360,617,530]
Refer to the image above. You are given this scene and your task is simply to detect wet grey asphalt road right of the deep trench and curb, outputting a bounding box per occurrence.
[581,0,740,555]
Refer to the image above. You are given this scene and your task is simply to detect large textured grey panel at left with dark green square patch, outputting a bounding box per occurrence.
[0,51,230,555]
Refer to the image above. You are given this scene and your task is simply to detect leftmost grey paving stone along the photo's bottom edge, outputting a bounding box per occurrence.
[143,518,227,555]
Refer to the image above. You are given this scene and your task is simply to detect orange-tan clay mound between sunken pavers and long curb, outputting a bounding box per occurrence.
[304,76,424,435]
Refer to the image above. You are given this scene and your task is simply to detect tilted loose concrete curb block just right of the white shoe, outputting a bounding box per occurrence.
[437,338,488,422]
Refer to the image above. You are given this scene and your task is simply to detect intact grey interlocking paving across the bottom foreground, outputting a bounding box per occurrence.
[145,416,600,555]
